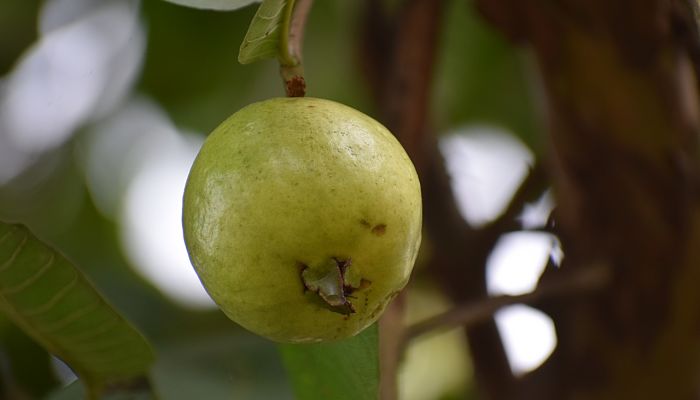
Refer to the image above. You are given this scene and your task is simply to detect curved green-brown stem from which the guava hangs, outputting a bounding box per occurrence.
[279,0,313,97]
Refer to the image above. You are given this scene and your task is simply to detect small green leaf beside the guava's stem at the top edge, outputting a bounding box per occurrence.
[238,0,295,65]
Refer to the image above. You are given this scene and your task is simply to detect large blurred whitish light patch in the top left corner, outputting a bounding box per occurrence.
[0,0,145,184]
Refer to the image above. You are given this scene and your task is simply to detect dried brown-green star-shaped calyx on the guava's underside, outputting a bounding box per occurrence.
[301,257,370,315]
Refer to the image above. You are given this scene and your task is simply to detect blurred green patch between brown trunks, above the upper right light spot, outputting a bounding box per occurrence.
[433,1,542,152]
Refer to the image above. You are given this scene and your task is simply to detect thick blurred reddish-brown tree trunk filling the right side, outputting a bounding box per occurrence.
[477,0,700,399]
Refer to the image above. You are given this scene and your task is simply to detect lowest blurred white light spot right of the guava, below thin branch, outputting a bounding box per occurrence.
[496,305,557,375]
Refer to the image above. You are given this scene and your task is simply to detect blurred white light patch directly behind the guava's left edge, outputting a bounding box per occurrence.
[79,97,214,307]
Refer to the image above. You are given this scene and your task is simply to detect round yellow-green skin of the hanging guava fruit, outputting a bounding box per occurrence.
[183,97,422,343]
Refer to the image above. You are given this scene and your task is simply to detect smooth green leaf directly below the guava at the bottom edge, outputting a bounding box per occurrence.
[279,324,379,400]
